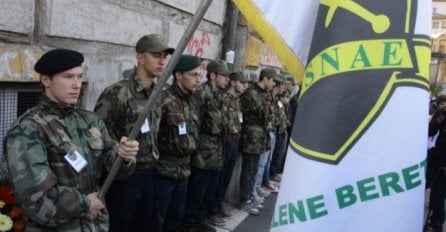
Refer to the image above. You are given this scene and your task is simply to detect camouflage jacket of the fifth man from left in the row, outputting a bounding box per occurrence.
[223,92,243,134]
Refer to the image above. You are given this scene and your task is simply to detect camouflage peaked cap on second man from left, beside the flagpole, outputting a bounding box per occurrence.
[135,34,175,54]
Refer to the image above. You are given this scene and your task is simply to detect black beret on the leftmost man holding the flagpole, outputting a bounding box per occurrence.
[34,48,84,75]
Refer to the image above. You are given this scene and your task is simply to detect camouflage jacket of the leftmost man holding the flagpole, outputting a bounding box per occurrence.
[5,96,134,231]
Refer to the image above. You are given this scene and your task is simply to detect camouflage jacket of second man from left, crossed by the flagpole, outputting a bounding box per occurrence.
[94,68,161,163]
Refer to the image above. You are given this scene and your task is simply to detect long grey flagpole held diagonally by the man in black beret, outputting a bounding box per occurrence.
[98,0,212,199]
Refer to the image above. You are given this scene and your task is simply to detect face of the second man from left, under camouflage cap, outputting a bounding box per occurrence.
[136,52,168,78]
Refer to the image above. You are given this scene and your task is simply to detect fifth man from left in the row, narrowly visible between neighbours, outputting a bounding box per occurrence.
[209,71,249,220]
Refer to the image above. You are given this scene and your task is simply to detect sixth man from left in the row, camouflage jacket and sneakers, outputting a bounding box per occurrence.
[240,68,277,215]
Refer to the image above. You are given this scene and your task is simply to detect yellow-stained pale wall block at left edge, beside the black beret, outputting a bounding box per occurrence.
[0,46,42,82]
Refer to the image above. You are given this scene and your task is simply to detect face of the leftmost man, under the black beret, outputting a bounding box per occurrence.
[41,67,84,105]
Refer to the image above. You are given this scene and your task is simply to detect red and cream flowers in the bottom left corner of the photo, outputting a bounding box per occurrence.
[0,160,28,232]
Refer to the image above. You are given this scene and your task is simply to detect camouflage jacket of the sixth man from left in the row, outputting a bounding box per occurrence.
[239,83,271,155]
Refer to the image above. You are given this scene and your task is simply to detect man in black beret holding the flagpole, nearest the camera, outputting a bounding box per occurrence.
[5,49,138,232]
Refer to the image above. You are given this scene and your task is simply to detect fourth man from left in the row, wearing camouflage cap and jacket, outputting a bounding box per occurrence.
[184,61,231,231]
